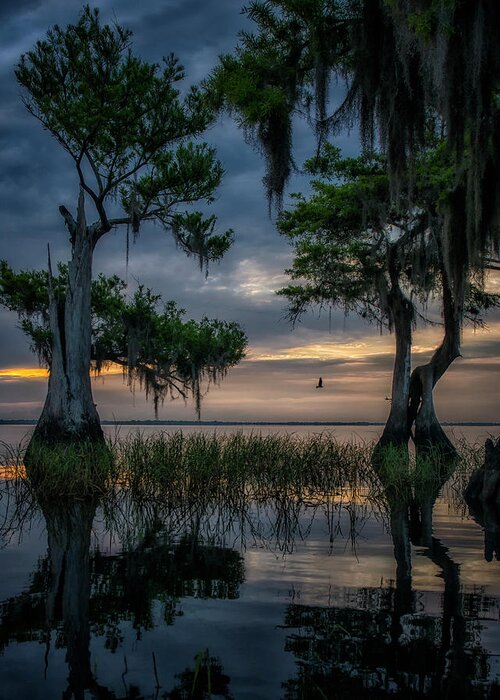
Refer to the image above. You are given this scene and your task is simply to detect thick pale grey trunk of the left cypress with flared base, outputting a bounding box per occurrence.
[32,190,103,444]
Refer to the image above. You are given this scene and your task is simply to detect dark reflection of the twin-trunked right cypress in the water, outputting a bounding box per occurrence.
[285,478,500,700]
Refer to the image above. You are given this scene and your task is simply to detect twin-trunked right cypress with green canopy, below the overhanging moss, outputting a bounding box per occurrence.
[278,143,500,453]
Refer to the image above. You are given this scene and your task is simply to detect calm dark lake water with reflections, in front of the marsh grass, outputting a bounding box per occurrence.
[0,424,500,700]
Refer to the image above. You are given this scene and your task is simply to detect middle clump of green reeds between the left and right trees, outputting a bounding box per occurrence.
[116,432,371,496]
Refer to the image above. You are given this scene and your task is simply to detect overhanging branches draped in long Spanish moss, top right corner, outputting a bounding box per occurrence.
[213,0,500,311]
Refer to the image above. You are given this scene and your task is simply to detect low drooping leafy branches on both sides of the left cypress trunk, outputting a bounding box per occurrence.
[0,261,247,411]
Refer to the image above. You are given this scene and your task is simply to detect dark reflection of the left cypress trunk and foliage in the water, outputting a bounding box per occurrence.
[0,492,244,700]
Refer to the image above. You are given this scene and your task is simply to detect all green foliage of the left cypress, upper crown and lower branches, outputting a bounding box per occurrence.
[0,5,247,420]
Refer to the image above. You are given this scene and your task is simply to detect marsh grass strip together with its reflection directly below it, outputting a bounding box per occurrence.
[0,431,490,554]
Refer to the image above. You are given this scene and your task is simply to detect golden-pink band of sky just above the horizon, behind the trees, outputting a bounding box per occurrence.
[0,312,500,422]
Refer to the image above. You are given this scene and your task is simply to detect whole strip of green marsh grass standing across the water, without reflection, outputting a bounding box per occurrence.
[0,431,483,504]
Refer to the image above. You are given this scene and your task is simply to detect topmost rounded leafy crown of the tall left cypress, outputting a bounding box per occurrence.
[16,6,212,191]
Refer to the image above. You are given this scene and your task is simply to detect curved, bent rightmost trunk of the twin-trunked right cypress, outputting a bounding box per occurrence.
[408,269,463,457]
